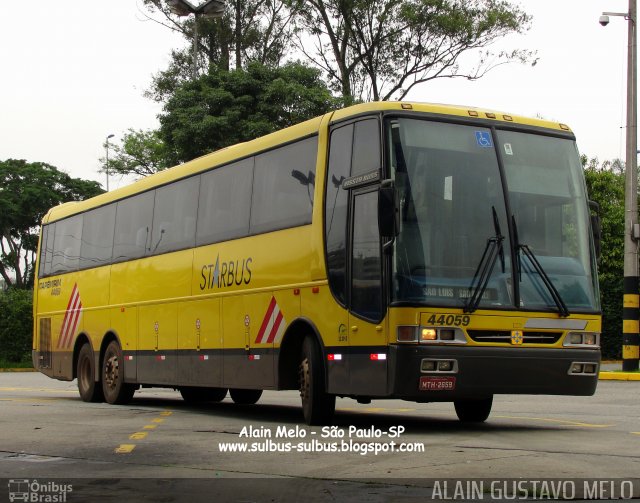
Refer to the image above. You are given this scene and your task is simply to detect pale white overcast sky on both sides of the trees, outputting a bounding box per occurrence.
[0,0,628,189]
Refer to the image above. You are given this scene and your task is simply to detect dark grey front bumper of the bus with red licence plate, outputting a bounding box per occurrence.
[388,345,600,402]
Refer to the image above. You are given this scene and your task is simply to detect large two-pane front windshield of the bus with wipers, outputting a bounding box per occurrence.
[387,118,599,316]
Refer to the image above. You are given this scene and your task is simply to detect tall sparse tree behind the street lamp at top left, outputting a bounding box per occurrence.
[144,0,295,102]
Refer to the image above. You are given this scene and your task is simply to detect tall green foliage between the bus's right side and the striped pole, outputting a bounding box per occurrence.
[582,156,625,359]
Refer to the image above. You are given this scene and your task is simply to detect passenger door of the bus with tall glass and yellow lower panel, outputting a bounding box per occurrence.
[348,189,388,396]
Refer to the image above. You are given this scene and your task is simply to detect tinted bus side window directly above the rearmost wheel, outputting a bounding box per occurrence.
[80,204,116,268]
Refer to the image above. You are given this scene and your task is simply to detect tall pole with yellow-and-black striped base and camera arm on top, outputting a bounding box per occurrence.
[600,0,640,371]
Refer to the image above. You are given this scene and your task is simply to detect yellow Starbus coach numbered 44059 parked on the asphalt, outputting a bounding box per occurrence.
[33,102,601,424]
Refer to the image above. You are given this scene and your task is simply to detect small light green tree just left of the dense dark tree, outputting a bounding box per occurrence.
[100,129,175,177]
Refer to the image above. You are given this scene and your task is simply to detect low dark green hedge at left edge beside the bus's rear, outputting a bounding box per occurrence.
[0,288,33,364]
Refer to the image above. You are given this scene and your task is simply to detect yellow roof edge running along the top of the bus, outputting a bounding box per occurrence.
[43,101,571,223]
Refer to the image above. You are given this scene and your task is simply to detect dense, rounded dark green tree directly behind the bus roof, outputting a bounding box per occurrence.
[159,63,338,162]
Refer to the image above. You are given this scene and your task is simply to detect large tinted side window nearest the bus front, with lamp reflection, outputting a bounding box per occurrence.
[250,137,318,234]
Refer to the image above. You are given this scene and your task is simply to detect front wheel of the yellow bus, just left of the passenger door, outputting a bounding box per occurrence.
[299,336,336,426]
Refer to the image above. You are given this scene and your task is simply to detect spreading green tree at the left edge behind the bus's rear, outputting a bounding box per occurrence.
[0,159,103,288]
